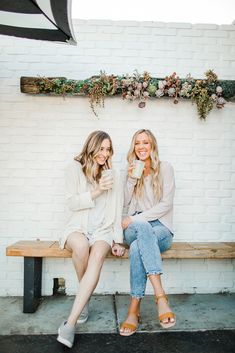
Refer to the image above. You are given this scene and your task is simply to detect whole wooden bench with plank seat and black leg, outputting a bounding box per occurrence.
[6,240,235,313]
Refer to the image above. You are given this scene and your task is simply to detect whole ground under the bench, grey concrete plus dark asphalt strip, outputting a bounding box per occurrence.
[0,294,235,353]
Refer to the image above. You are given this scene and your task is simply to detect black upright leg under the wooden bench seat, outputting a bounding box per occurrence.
[23,257,42,313]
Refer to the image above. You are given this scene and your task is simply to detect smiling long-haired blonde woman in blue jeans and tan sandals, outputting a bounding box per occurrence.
[120,129,176,336]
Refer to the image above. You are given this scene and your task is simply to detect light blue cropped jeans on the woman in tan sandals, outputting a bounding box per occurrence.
[124,220,173,298]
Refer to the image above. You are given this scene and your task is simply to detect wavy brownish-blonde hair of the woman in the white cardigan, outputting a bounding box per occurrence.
[74,130,113,184]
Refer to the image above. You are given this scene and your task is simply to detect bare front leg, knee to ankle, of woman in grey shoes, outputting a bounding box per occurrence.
[67,240,110,326]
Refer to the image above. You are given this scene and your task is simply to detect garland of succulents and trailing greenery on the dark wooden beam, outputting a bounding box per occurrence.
[37,70,235,120]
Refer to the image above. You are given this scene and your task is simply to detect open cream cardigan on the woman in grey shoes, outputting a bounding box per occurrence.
[60,160,123,249]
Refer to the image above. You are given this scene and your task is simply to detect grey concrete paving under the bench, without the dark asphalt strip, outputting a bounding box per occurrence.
[0,294,235,332]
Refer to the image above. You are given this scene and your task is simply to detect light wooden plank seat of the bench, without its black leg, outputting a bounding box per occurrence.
[6,240,235,259]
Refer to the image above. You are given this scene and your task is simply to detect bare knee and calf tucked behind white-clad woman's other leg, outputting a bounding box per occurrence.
[65,232,89,282]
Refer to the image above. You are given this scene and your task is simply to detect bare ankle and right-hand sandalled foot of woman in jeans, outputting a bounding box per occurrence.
[149,275,175,323]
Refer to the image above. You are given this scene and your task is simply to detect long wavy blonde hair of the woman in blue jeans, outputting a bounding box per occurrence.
[127,129,162,201]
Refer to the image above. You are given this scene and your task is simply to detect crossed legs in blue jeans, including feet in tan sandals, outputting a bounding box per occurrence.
[120,221,174,335]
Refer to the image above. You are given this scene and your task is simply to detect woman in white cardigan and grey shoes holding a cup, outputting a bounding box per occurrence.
[57,131,124,348]
